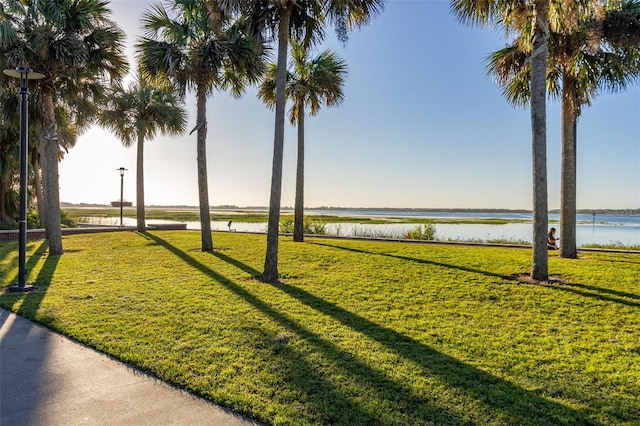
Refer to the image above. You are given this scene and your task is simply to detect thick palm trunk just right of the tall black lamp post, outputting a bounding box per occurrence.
[42,88,63,256]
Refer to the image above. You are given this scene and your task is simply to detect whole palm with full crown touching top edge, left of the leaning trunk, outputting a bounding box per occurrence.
[137,0,264,251]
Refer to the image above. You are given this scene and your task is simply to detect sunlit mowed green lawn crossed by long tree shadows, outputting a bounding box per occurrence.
[0,231,640,425]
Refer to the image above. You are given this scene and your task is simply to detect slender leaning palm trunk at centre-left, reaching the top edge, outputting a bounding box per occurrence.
[262,4,292,282]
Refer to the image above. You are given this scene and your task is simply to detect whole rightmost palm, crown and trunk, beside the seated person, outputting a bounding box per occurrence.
[554,0,640,259]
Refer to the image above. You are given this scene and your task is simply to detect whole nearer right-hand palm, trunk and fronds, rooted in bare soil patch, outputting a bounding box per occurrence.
[452,0,549,281]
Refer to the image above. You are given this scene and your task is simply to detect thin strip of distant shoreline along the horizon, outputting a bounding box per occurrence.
[60,202,640,216]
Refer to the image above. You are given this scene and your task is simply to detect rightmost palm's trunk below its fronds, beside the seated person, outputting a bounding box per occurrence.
[559,73,578,259]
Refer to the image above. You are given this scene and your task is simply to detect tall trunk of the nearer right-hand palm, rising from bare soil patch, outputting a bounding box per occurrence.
[531,0,549,281]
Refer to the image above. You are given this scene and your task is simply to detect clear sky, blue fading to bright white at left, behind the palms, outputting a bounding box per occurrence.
[60,0,640,209]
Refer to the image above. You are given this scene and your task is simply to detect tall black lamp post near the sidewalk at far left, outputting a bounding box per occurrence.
[4,66,44,292]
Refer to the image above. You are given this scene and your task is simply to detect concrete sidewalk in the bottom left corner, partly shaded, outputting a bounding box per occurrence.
[0,309,257,426]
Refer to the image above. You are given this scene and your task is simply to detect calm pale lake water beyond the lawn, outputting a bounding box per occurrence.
[125,209,640,246]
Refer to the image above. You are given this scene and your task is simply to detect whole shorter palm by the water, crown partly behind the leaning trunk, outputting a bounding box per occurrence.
[258,40,347,242]
